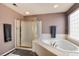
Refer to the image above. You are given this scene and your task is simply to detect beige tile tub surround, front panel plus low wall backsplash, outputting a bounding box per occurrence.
[32,33,66,56]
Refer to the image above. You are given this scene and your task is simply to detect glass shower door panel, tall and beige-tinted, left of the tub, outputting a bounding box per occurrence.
[21,21,34,47]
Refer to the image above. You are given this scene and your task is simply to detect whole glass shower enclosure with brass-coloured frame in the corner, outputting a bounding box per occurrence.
[15,20,41,48]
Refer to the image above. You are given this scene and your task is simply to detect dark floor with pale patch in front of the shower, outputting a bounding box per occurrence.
[6,49,37,56]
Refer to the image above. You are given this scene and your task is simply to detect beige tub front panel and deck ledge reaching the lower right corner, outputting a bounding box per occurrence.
[32,40,79,56]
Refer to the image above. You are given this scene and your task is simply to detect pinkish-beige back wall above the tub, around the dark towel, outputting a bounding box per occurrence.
[24,14,65,34]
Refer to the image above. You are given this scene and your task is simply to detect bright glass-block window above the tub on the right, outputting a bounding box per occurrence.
[69,10,79,40]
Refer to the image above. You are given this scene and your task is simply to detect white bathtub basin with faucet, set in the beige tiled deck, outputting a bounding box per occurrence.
[41,39,79,56]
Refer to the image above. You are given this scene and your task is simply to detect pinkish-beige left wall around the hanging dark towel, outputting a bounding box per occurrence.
[0,4,22,55]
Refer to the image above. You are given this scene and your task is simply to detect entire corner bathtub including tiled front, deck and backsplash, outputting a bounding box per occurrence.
[32,34,79,56]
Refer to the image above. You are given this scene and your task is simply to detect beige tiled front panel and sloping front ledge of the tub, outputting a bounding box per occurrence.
[32,40,63,56]
